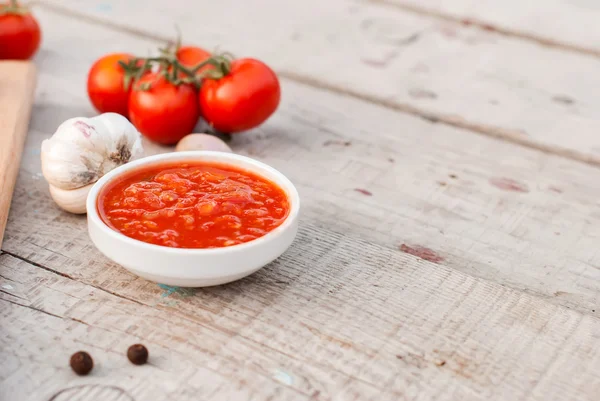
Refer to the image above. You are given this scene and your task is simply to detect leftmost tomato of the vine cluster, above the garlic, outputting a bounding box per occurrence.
[87,53,134,117]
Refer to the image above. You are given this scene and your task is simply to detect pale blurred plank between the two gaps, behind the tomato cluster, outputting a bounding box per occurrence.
[34,0,600,164]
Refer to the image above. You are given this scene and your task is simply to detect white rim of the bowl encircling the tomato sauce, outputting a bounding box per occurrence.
[86,150,300,255]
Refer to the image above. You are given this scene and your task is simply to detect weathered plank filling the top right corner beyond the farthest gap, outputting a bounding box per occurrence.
[367,0,600,56]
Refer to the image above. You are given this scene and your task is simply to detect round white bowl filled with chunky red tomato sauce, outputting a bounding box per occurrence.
[86,151,300,287]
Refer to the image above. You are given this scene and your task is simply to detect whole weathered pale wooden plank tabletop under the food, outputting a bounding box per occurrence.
[0,0,600,401]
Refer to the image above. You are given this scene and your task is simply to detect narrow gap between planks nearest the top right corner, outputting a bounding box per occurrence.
[361,0,600,57]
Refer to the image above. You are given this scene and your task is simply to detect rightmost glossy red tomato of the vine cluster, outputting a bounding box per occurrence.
[199,58,281,133]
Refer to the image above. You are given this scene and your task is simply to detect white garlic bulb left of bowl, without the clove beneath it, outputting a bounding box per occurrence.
[42,113,143,190]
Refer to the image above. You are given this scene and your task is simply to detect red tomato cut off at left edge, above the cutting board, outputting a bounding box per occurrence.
[0,3,42,60]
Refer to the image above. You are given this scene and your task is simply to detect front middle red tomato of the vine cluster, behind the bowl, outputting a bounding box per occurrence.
[129,73,200,145]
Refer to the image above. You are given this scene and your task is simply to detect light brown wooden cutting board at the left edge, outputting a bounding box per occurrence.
[0,61,36,246]
